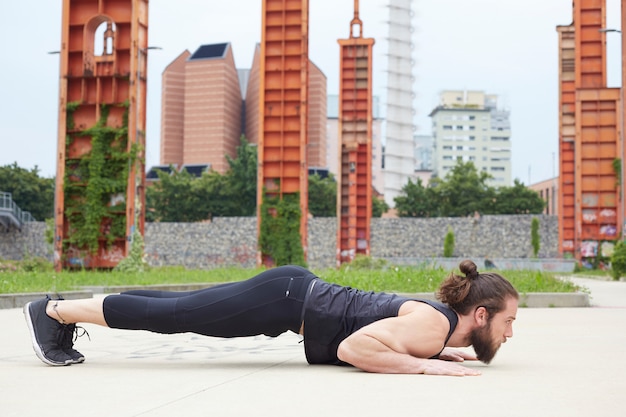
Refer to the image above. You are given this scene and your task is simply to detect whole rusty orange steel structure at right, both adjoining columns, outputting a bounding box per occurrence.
[557,0,624,260]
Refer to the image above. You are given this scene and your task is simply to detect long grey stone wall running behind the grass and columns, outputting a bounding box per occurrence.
[0,215,558,269]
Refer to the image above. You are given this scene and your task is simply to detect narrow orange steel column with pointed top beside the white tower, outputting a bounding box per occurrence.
[337,0,374,266]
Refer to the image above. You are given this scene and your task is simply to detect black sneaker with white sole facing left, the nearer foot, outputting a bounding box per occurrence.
[24,296,72,366]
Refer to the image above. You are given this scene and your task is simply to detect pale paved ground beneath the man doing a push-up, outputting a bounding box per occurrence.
[0,279,626,417]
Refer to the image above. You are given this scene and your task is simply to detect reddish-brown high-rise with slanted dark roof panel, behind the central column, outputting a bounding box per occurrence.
[158,43,327,177]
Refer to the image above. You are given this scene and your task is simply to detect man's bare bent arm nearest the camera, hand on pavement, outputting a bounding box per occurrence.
[337,310,480,376]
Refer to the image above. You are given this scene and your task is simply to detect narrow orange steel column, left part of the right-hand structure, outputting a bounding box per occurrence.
[557,25,577,257]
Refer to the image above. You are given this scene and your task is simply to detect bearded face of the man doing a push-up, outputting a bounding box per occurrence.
[470,298,517,363]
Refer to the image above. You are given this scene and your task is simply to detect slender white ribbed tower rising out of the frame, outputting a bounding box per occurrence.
[384,0,415,207]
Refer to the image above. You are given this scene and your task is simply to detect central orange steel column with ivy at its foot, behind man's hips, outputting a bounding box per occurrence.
[257,0,309,266]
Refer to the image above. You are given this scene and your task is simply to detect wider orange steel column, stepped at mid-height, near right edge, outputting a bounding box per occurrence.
[574,0,622,260]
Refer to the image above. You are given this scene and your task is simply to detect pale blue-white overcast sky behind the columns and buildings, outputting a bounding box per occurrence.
[0,0,621,188]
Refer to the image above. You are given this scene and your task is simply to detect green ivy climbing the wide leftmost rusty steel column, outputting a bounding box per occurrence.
[64,104,139,254]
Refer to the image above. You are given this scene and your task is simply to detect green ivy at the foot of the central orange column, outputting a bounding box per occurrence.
[259,192,306,266]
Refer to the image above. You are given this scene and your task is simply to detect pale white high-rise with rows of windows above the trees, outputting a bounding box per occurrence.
[430,91,511,187]
